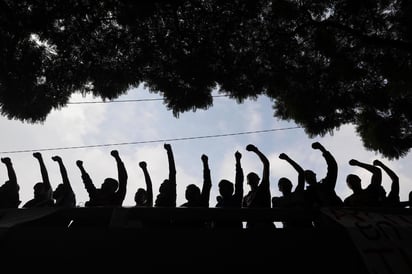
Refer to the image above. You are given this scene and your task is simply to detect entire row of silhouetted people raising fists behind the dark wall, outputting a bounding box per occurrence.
[0,142,412,227]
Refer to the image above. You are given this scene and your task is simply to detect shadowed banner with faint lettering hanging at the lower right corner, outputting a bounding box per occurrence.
[322,208,412,274]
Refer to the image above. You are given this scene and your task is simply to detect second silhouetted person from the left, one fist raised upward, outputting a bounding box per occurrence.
[23,152,54,208]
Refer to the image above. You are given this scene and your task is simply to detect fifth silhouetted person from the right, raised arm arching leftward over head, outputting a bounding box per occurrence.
[243,144,274,228]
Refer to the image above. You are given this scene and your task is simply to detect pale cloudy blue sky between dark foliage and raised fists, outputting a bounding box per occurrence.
[0,84,412,206]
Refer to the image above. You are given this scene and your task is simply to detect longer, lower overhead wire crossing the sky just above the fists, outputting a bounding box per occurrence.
[0,127,301,154]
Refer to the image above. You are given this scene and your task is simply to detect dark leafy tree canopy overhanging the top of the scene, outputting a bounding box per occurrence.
[0,0,412,158]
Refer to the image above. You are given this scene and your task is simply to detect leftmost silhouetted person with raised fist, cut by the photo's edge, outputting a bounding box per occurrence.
[0,157,21,208]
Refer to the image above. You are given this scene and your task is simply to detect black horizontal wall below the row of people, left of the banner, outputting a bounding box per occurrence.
[0,208,374,273]
